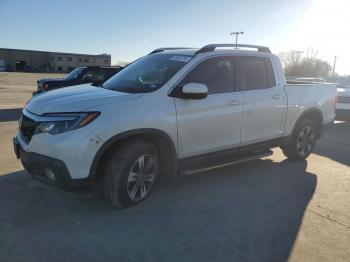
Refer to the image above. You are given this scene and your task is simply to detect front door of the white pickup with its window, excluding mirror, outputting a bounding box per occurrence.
[175,56,242,158]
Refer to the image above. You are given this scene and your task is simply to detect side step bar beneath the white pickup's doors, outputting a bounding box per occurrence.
[179,150,273,175]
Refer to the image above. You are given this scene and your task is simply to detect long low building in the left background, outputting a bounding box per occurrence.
[0,48,111,72]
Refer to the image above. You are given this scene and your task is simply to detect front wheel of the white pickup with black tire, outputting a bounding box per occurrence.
[102,140,158,208]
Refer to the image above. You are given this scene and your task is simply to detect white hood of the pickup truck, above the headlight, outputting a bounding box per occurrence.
[25,84,142,115]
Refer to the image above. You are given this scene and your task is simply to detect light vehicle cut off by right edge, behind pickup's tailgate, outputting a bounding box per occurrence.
[336,77,350,120]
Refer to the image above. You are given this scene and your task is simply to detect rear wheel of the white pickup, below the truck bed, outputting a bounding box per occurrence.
[282,119,317,160]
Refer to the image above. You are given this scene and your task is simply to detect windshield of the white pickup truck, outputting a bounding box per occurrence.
[103,54,192,93]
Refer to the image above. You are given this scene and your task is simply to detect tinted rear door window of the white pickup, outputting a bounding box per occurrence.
[238,56,276,91]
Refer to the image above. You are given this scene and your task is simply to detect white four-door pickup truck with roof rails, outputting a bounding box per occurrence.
[14,44,336,207]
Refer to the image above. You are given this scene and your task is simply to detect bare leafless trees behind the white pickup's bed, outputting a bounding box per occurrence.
[280,48,332,78]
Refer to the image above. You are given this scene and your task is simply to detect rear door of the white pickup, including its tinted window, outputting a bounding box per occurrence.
[238,56,287,145]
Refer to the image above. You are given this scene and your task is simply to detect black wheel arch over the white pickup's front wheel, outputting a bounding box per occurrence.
[89,128,178,181]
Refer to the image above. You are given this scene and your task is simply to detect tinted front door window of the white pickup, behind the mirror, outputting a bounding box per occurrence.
[180,57,234,94]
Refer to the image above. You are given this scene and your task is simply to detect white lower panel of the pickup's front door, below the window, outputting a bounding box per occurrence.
[175,92,243,158]
